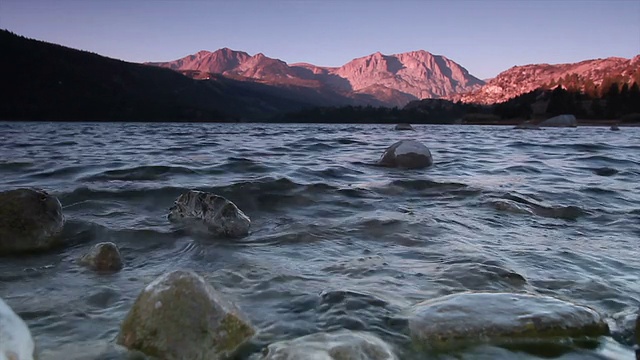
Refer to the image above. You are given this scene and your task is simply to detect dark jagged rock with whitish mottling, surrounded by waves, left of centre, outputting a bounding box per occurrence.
[168,190,251,237]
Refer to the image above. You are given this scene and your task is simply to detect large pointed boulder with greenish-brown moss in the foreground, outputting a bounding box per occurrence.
[117,270,255,360]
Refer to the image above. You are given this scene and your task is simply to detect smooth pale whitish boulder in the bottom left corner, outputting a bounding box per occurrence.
[0,299,35,360]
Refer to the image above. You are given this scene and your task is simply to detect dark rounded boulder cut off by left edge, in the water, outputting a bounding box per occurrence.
[0,189,64,255]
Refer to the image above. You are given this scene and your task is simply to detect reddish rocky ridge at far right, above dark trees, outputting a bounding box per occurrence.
[449,55,640,104]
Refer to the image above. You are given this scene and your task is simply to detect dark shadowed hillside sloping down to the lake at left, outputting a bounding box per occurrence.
[0,30,336,121]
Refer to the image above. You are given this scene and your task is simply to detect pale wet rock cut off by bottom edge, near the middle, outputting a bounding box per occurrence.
[262,330,397,360]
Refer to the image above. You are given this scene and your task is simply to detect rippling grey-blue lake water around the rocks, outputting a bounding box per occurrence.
[0,123,640,359]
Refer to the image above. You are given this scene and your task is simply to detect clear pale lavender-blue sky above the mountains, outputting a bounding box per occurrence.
[0,0,640,78]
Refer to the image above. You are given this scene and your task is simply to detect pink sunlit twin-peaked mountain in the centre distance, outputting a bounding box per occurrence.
[147,48,484,106]
